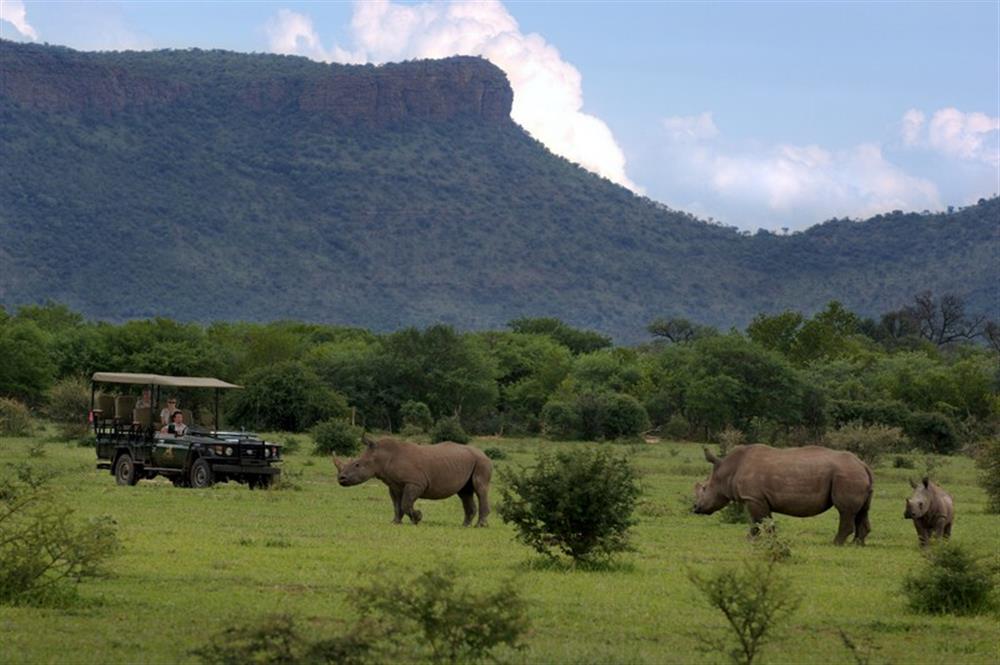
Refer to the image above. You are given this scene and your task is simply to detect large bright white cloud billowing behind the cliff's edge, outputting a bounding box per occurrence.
[268,0,641,191]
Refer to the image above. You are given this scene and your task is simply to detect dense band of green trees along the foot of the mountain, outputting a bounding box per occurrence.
[0,293,1000,452]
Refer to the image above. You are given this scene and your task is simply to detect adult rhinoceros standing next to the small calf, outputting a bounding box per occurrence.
[694,444,873,545]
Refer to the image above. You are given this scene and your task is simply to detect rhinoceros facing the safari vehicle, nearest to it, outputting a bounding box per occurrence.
[333,434,493,526]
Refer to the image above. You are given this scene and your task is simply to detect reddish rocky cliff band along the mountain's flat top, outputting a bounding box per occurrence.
[0,41,513,125]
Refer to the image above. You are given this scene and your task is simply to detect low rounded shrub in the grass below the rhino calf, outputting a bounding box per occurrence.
[903,541,993,614]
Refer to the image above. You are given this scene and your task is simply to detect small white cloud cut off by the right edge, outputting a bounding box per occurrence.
[902,108,1000,168]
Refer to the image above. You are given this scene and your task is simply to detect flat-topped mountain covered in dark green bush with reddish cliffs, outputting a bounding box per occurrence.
[0,41,1000,341]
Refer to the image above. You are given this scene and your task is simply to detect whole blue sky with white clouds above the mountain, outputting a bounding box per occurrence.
[0,0,1000,230]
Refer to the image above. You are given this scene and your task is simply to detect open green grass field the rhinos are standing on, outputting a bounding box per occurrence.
[0,438,1000,665]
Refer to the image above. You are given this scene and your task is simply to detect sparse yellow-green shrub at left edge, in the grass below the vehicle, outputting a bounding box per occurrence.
[0,467,120,604]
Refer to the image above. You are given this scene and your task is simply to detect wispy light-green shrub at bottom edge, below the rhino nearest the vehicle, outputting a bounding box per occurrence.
[358,568,528,664]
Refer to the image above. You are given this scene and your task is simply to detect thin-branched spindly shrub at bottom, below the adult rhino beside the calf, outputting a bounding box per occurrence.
[689,562,799,665]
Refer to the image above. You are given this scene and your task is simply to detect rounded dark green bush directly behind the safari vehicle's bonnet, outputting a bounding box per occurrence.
[229,361,350,432]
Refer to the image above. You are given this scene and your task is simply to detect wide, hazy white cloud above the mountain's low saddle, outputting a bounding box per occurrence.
[660,113,941,228]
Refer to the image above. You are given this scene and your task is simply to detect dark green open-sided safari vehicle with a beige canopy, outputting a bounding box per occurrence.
[90,372,281,489]
